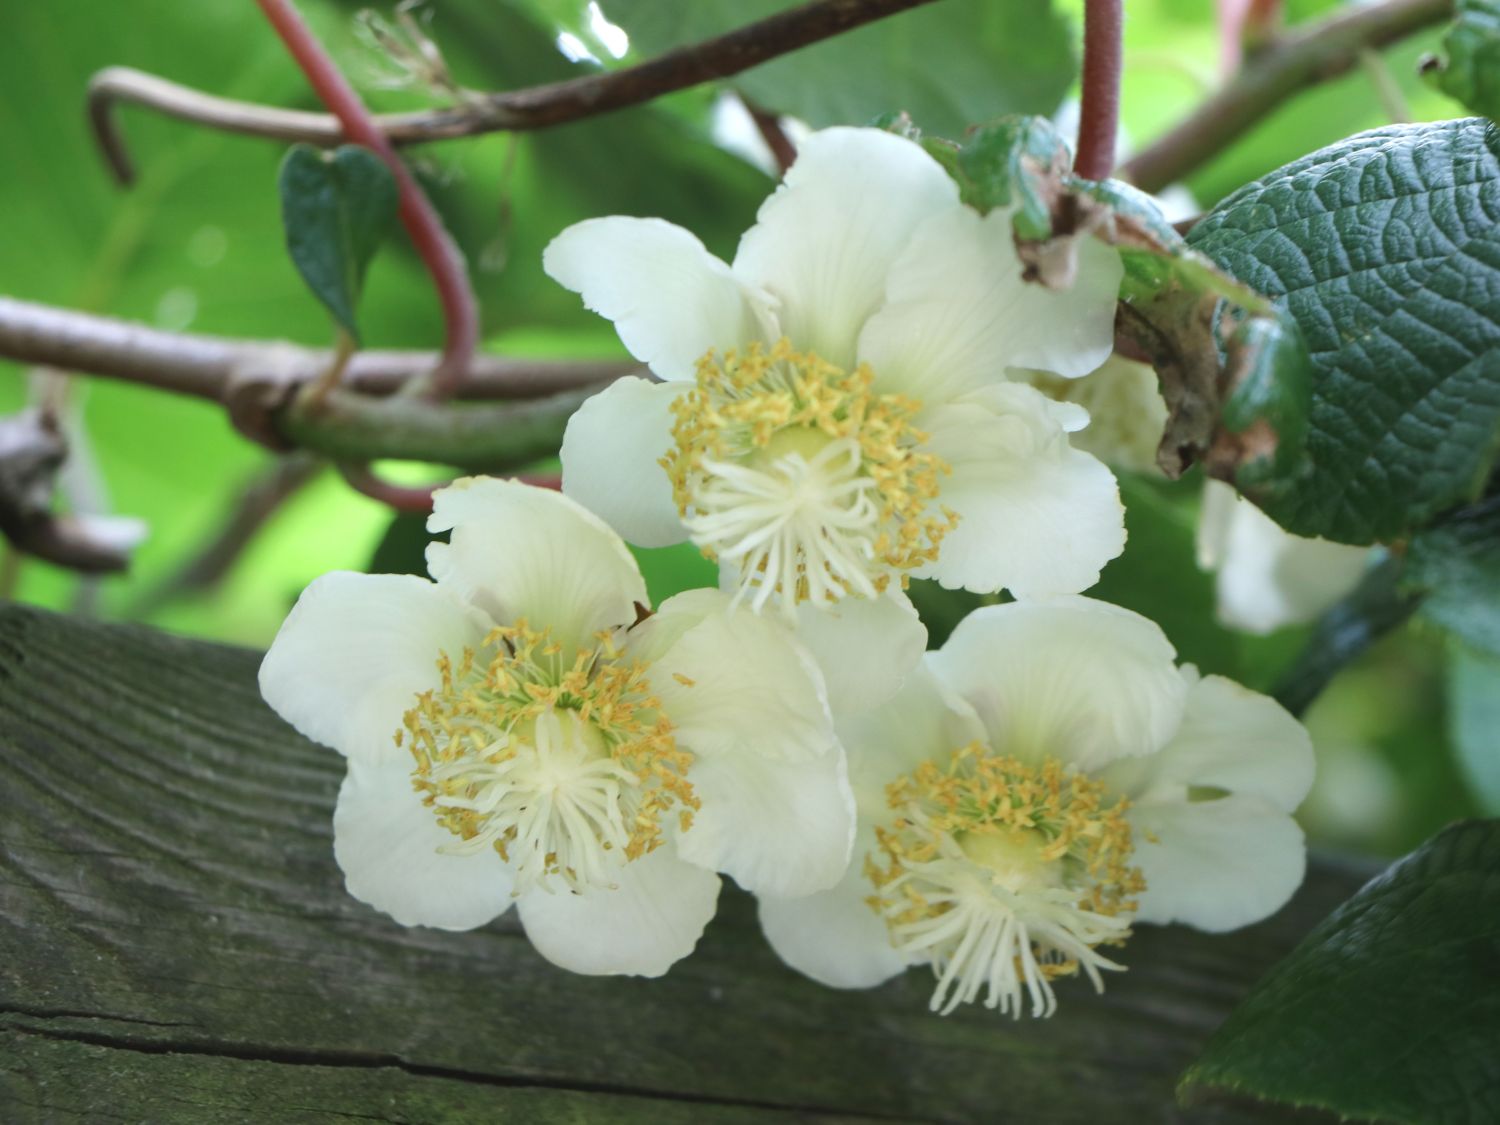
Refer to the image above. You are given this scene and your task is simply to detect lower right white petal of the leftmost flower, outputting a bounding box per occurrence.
[678,746,854,896]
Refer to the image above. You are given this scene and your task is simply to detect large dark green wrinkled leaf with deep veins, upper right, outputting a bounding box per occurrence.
[1188,119,1500,543]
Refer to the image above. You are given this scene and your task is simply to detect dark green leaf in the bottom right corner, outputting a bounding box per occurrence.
[1179,821,1500,1125]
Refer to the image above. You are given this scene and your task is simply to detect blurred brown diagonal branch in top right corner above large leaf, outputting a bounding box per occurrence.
[1119,0,1454,192]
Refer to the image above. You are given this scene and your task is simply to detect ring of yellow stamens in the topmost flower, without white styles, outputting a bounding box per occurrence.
[662,338,957,600]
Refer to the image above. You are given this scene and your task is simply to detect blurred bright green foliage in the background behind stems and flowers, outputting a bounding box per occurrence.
[0,0,1493,854]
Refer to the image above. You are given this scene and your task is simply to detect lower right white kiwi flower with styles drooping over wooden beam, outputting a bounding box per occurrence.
[761,596,1313,1019]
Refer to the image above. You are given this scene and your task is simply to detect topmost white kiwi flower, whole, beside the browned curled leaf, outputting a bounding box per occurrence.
[543,128,1125,627]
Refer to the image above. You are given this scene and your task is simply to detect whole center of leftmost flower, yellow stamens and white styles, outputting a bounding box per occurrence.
[396,623,699,893]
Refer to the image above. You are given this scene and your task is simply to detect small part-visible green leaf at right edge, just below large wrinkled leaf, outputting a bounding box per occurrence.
[1406,497,1500,656]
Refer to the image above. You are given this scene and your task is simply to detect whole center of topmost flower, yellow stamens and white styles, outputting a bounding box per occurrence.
[662,339,957,611]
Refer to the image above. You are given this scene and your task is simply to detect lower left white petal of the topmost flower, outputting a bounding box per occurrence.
[563,378,687,548]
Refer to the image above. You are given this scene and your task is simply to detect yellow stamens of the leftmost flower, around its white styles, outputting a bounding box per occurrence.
[396,621,699,875]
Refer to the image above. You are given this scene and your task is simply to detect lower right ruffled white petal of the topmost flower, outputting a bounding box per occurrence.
[915,384,1125,597]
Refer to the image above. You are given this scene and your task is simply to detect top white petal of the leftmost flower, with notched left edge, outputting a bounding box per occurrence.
[428,477,647,657]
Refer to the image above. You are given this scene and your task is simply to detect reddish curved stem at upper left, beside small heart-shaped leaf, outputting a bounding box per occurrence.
[255,0,479,398]
